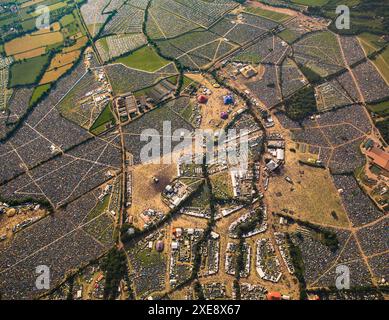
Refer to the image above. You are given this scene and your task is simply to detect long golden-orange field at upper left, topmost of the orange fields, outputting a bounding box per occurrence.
[4,31,63,56]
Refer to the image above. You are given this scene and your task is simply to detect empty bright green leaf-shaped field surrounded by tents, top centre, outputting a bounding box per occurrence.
[114,47,169,72]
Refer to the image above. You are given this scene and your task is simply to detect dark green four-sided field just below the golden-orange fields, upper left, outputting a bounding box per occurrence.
[9,55,49,88]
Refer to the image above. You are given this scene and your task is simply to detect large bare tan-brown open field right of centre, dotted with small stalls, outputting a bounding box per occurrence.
[267,148,349,227]
